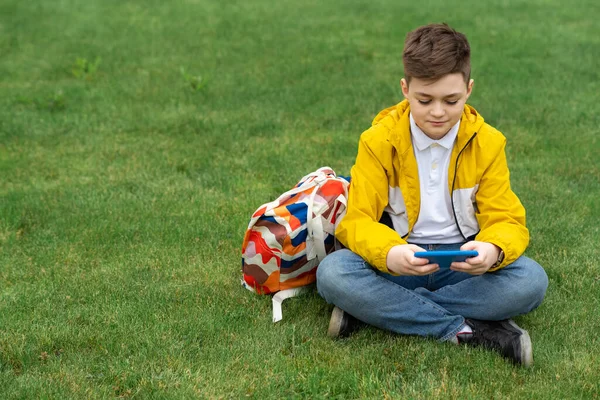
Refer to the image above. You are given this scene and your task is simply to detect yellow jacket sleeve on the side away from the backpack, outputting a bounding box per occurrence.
[475,138,529,271]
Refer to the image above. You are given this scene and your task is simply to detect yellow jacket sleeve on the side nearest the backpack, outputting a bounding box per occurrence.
[336,128,406,273]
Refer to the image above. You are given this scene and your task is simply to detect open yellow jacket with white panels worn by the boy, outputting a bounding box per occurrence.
[336,100,529,272]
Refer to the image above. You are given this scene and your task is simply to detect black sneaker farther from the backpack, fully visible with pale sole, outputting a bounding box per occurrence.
[457,319,533,367]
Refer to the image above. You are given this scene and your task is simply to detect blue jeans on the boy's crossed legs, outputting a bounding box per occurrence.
[317,243,548,341]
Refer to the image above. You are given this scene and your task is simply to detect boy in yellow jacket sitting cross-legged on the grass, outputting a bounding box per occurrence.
[317,24,548,366]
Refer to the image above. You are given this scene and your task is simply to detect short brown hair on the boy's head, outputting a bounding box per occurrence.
[402,24,471,83]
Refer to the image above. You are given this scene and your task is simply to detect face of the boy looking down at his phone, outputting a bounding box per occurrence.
[400,73,473,140]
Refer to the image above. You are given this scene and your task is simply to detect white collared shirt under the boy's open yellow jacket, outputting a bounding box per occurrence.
[408,114,464,244]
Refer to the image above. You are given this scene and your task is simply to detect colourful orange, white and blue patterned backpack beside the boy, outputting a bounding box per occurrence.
[242,167,349,322]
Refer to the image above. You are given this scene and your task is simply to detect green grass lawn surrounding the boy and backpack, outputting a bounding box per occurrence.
[0,0,600,399]
